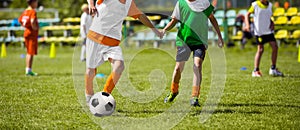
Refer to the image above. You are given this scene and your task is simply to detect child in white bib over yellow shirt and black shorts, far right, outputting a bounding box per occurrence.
[245,0,283,77]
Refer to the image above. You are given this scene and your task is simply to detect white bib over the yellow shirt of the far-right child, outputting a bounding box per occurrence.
[252,1,273,36]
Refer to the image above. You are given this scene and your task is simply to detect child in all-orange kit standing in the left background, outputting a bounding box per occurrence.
[18,0,39,76]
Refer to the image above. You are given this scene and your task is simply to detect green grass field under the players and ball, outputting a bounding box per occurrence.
[0,42,300,130]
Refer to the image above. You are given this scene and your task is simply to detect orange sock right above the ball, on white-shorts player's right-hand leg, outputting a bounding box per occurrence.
[103,72,121,93]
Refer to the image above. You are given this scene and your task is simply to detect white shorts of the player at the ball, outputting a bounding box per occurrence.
[86,38,124,68]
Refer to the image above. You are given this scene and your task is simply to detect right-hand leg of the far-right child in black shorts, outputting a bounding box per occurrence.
[269,34,283,76]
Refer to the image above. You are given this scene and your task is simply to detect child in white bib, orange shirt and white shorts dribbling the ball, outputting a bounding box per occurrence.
[85,0,161,102]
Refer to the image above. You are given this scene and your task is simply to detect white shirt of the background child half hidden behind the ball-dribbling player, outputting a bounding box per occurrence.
[80,12,93,38]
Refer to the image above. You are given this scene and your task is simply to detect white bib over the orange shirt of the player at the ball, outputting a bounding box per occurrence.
[90,0,132,40]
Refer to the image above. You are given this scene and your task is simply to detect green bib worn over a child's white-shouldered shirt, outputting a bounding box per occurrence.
[174,0,214,46]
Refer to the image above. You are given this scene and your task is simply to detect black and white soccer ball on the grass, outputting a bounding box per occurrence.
[89,92,116,117]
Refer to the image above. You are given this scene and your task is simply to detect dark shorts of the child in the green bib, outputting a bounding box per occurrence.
[176,44,206,62]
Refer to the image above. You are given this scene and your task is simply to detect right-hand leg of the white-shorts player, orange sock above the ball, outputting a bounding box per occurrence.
[103,58,124,93]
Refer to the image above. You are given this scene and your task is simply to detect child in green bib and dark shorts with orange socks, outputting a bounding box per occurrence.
[162,0,224,106]
